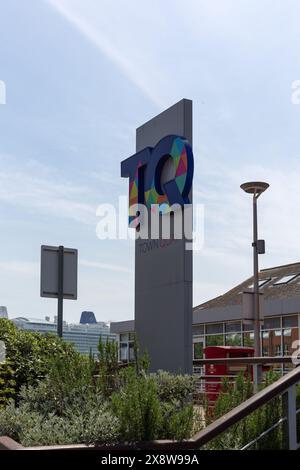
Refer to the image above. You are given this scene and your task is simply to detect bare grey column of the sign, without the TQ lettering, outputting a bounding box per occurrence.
[135,99,193,374]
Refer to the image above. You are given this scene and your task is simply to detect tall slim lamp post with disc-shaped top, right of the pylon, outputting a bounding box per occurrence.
[241,181,269,388]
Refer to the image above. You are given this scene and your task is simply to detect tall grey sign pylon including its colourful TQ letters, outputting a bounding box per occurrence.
[121,99,193,373]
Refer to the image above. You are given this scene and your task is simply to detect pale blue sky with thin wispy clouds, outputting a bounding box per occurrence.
[0,0,300,321]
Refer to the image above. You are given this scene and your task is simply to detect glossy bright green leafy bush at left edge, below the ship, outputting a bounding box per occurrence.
[0,318,79,395]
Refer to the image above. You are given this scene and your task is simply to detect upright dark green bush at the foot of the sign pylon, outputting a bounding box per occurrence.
[111,367,193,442]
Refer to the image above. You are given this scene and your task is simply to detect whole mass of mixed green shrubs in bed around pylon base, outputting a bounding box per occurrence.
[0,319,194,446]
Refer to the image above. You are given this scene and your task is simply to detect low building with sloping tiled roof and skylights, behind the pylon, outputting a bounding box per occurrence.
[111,263,300,370]
